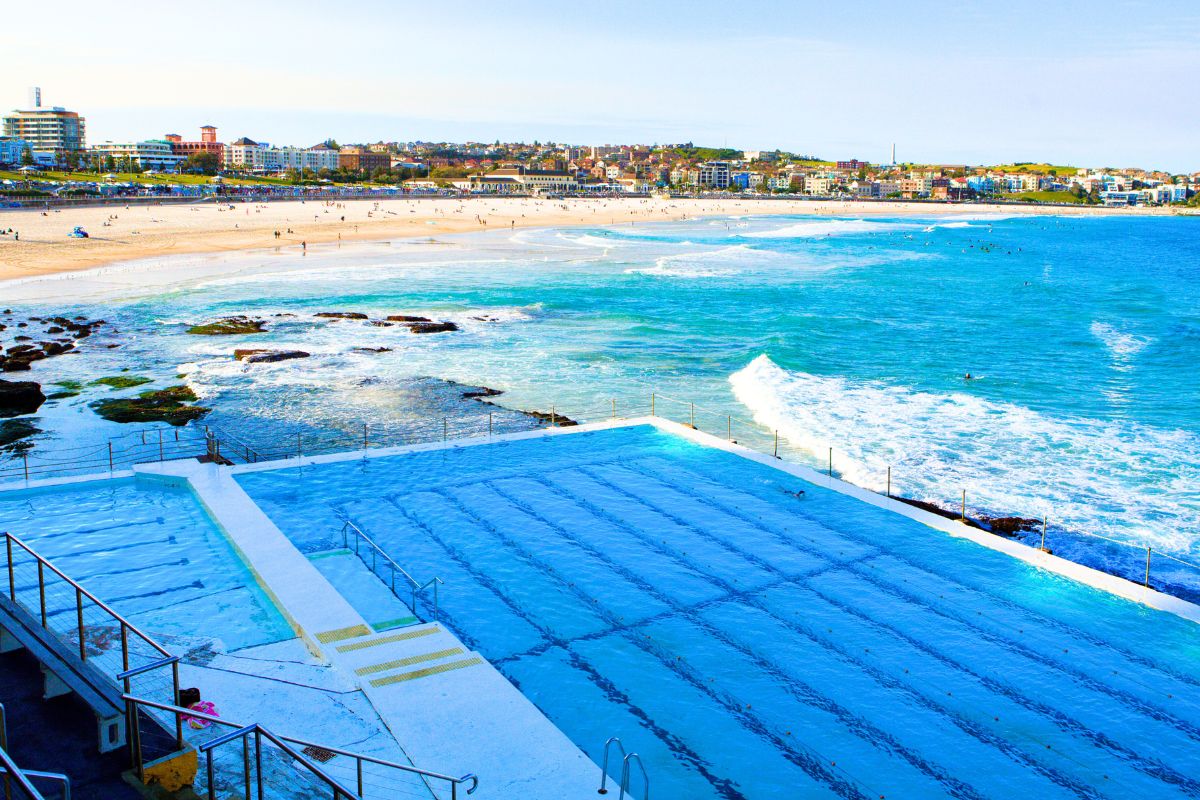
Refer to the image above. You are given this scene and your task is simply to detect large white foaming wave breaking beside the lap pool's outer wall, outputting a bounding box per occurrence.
[730,355,1200,554]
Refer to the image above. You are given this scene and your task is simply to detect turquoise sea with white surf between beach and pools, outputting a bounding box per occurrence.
[0,213,1200,581]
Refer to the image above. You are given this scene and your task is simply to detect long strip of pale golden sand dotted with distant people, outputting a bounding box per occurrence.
[0,197,1170,281]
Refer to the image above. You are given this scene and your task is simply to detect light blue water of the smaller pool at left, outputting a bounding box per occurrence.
[0,479,294,655]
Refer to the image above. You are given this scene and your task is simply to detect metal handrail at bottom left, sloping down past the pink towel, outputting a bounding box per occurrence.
[124,694,479,800]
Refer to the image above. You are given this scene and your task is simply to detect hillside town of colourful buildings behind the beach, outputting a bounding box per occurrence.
[0,88,1200,206]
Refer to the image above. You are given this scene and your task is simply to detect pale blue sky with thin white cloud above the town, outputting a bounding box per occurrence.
[0,0,1200,172]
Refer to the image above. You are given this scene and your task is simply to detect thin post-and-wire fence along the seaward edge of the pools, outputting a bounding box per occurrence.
[0,392,1200,602]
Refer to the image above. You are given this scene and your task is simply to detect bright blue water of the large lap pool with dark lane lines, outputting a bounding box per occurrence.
[238,426,1200,800]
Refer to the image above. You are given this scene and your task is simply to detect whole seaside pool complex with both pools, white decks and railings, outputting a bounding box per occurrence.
[0,410,1200,800]
